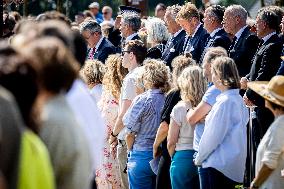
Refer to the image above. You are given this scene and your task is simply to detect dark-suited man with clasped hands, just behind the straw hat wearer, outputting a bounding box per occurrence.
[241,9,282,183]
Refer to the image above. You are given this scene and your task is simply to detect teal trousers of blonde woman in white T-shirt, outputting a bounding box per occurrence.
[170,150,199,189]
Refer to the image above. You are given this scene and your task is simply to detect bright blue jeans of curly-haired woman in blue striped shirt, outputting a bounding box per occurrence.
[127,151,156,189]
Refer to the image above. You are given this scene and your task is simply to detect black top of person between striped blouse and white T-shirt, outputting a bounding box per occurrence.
[161,90,181,159]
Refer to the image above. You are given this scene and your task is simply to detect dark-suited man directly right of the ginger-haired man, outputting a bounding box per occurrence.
[201,5,231,62]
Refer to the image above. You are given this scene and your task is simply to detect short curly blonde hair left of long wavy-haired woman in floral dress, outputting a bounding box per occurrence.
[80,60,105,85]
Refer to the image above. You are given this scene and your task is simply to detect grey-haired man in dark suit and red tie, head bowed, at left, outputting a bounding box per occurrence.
[80,21,116,63]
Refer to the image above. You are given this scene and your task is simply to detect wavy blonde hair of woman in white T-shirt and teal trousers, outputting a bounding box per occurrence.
[178,65,207,107]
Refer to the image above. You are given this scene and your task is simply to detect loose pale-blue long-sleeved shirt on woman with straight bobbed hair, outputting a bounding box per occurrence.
[195,89,249,182]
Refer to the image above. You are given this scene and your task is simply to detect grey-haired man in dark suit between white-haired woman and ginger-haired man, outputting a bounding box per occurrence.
[161,5,186,69]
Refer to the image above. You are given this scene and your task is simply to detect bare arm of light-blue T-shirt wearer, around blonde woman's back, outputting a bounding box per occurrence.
[186,101,212,125]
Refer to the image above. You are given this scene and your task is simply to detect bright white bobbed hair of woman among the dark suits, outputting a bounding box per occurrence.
[145,18,169,43]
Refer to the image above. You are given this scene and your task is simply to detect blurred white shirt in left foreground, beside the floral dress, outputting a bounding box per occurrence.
[66,79,107,174]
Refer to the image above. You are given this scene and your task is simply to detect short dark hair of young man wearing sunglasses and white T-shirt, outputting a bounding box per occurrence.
[125,40,147,64]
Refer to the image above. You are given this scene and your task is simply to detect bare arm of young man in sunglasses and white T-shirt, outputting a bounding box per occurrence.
[109,100,132,144]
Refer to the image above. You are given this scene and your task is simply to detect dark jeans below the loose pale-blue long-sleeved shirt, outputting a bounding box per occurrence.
[198,167,239,189]
